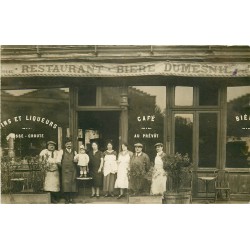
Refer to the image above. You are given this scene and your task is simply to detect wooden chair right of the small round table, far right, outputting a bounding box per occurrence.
[214,169,231,201]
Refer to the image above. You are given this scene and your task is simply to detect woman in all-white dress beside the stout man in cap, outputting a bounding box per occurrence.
[115,143,133,199]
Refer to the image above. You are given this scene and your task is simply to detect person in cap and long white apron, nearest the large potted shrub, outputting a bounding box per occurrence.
[150,143,167,195]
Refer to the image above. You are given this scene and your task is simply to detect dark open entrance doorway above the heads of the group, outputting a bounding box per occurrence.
[78,111,120,151]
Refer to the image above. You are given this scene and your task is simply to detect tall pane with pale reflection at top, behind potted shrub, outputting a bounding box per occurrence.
[174,114,193,159]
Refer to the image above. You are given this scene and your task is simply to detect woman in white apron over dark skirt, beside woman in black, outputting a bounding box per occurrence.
[103,142,117,197]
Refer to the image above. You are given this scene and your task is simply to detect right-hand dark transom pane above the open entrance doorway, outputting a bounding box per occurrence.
[101,87,120,106]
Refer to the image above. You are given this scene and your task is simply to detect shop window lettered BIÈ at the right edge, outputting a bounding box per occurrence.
[226,86,250,168]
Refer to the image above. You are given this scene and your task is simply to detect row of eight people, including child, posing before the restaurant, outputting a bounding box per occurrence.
[40,139,167,203]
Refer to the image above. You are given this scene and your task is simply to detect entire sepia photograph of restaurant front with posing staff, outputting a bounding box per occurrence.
[1,45,250,204]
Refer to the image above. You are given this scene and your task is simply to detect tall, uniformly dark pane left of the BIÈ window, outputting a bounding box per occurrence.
[199,113,217,168]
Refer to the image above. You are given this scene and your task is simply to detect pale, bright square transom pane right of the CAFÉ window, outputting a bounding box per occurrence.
[175,86,193,106]
